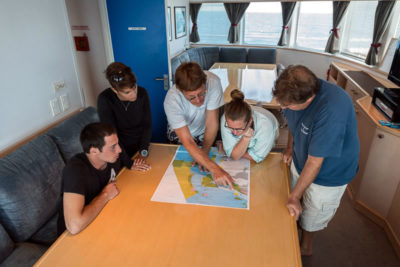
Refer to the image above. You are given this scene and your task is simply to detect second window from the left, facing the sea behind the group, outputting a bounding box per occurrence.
[243,2,282,45]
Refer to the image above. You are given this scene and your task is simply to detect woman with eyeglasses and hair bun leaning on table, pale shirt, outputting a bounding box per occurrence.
[221,89,279,163]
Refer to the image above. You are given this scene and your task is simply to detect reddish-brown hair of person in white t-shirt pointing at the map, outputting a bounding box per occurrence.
[175,62,207,91]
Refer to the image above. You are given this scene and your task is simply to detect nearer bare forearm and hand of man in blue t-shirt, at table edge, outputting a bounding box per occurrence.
[286,155,324,220]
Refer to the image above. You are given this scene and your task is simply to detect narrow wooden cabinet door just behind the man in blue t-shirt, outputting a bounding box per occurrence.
[349,109,376,199]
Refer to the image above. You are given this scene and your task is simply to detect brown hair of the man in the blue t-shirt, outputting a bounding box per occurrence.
[272,65,320,105]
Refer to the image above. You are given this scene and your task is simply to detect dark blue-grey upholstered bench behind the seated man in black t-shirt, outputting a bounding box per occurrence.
[0,107,99,266]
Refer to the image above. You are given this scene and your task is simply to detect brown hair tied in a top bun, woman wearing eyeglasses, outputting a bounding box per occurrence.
[225,89,251,122]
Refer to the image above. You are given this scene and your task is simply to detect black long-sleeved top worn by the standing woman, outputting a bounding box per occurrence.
[97,86,152,156]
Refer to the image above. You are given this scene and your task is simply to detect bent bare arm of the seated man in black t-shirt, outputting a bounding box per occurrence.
[63,182,119,235]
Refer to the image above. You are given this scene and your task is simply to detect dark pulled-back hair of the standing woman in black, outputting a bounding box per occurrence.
[105,62,136,91]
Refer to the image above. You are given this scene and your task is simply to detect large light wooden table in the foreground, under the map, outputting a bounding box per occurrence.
[36,144,301,267]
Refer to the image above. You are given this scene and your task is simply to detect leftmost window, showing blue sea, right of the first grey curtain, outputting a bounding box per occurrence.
[195,3,231,44]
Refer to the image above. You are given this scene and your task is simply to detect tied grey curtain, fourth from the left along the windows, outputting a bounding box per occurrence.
[325,1,350,53]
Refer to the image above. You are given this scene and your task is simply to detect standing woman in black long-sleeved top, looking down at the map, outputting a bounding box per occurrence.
[97,62,151,163]
